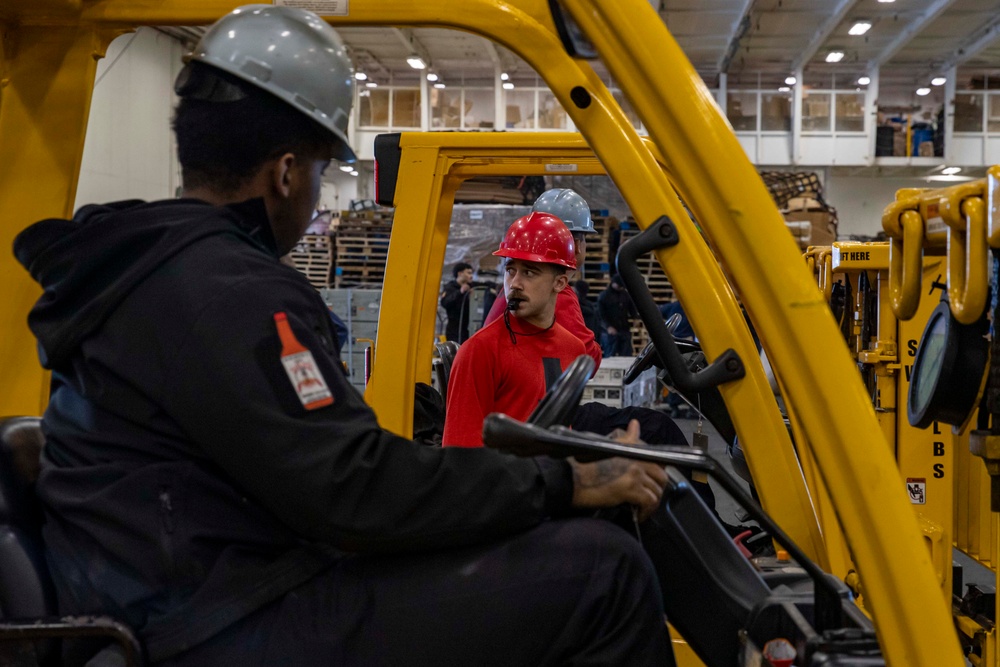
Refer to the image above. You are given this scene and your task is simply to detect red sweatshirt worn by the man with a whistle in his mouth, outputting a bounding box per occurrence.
[442,314,587,447]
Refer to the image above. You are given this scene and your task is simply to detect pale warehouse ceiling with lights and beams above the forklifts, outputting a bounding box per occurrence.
[160,0,1000,90]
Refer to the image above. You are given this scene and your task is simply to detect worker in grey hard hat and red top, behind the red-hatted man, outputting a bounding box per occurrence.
[484,188,602,369]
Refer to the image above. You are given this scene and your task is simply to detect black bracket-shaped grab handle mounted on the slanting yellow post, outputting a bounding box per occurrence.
[615,215,746,394]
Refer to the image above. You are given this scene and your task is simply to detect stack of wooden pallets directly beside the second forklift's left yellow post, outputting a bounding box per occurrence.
[333,210,392,287]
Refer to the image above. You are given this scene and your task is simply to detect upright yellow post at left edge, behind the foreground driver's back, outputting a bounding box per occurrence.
[0,25,118,415]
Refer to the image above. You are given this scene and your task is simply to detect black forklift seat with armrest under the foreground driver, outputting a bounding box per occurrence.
[0,417,142,667]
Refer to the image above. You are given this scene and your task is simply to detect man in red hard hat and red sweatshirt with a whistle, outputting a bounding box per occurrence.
[443,213,587,447]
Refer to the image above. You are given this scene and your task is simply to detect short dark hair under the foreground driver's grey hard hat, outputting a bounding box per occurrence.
[173,62,337,192]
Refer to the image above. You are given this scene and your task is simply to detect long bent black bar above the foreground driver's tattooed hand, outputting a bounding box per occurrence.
[483,412,844,634]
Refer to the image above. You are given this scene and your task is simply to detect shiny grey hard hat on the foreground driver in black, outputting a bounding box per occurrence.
[184,5,355,162]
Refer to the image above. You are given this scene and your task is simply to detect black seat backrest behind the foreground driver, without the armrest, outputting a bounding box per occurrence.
[0,417,56,619]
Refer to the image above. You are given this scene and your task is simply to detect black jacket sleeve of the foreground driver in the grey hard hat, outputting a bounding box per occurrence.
[163,278,572,551]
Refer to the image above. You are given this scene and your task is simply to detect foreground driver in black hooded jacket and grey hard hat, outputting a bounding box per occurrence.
[15,5,672,667]
